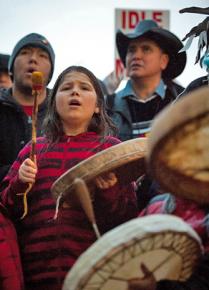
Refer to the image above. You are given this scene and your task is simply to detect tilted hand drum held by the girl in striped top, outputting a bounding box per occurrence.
[51,138,147,203]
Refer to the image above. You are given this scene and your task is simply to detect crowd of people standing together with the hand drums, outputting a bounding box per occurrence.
[0,5,209,290]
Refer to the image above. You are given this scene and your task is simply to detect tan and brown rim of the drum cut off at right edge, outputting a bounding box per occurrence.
[146,87,209,204]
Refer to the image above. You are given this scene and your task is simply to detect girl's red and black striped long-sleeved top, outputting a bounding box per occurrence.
[1,132,137,290]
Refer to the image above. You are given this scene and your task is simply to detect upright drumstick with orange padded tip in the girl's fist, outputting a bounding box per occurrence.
[21,71,43,219]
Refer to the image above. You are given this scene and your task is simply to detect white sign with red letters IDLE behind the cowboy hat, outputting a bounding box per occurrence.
[115,9,170,76]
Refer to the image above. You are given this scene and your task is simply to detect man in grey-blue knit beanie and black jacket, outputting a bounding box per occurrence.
[0,33,55,180]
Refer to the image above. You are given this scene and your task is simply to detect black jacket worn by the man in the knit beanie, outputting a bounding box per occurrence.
[0,89,49,181]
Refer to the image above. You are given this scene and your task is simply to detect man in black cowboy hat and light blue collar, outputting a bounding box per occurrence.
[107,20,186,140]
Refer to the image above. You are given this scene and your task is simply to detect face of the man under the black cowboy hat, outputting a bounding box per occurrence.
[126,38,169,78]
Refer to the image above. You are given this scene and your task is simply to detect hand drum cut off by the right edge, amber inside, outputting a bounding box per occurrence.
[147,87,209,204]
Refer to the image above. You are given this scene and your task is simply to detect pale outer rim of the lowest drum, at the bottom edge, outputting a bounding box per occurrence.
[63,214,203,290]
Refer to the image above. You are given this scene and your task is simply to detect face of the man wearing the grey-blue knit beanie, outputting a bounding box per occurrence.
[13,46,51,88]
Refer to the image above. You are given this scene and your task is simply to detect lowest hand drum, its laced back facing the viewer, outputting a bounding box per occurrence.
[62,214,202,290]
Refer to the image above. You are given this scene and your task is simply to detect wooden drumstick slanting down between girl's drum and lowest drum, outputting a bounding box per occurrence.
[73,178,101,239]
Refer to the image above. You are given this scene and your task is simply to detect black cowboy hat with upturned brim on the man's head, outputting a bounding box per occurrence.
[116,20,186,79]
